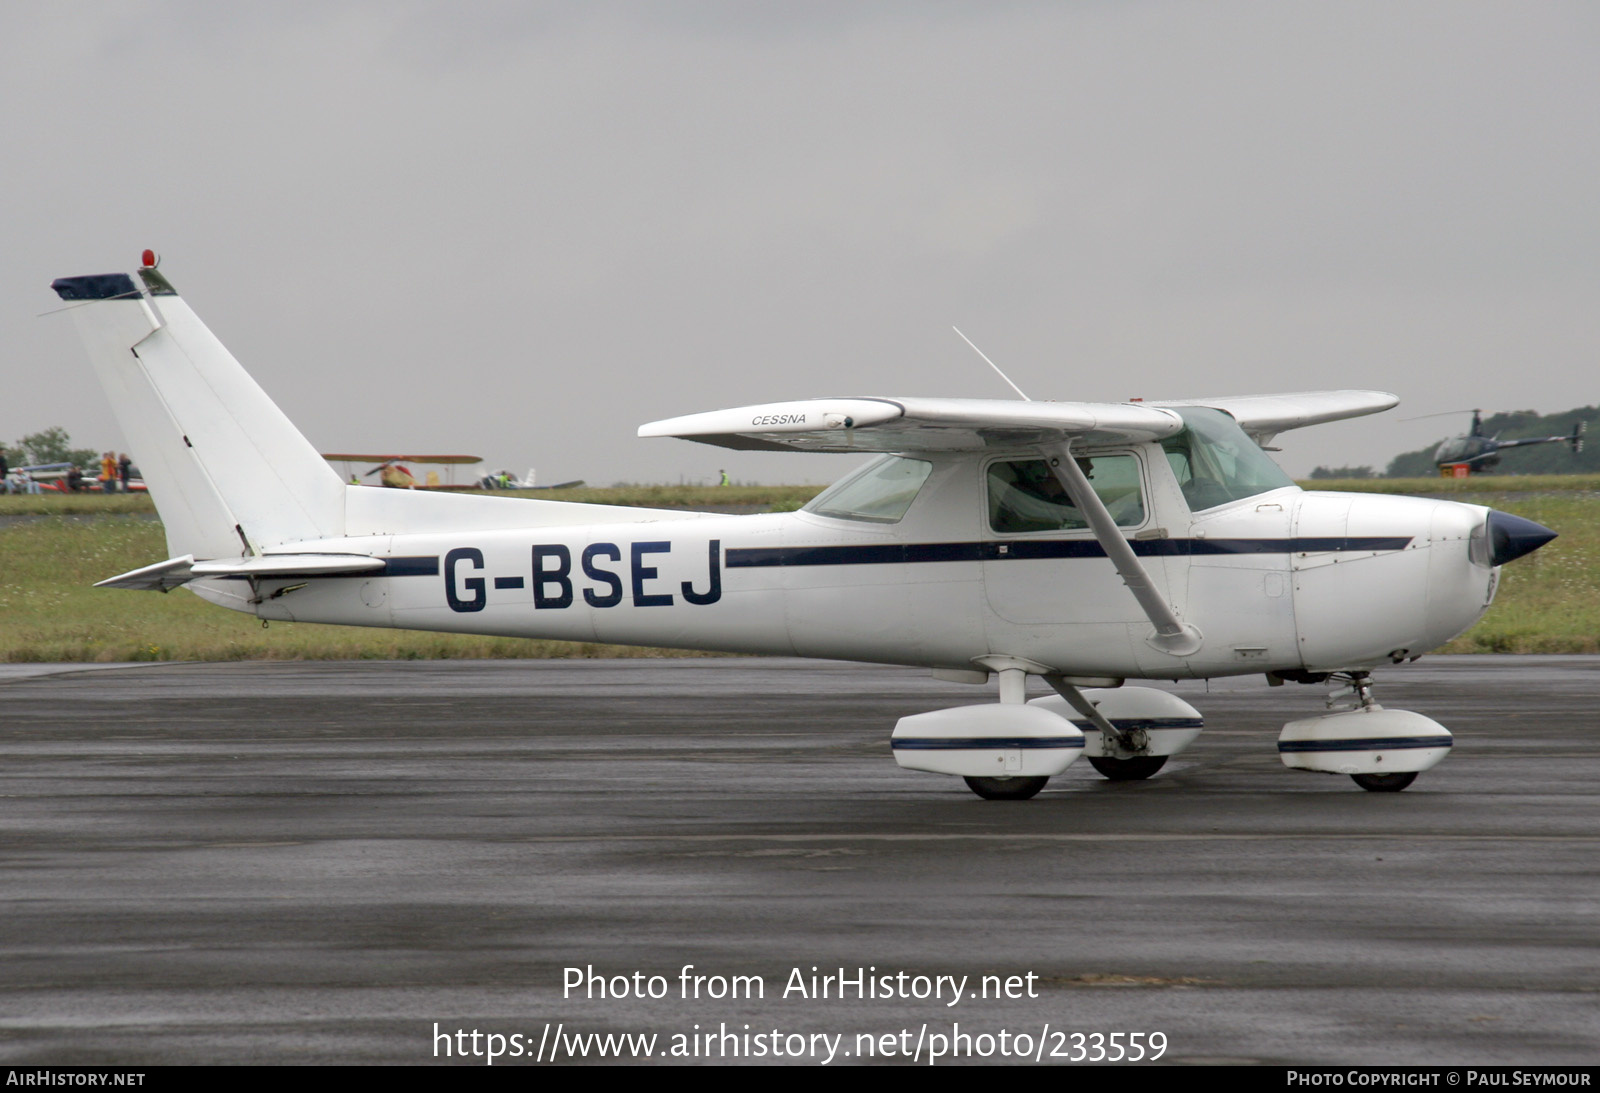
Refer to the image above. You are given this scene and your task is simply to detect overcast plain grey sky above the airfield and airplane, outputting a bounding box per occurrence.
[0,0,1600,485]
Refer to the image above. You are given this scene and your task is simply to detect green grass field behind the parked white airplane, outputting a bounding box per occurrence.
[0,475,1600,663]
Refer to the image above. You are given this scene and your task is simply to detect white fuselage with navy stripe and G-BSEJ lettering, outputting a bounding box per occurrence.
[190,445,1494,679]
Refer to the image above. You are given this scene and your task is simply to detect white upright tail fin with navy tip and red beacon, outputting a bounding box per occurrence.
[51,259,344,559]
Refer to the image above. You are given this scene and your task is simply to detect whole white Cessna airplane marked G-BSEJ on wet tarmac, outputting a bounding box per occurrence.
[53,251,1554,799]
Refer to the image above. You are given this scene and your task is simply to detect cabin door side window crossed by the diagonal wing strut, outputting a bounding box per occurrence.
[989,456,1144,531]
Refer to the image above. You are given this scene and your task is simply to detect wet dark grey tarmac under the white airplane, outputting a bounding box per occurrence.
[0,656,1600,1066]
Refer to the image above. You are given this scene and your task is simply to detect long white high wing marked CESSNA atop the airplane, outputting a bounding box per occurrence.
[638,390,1400,453]
